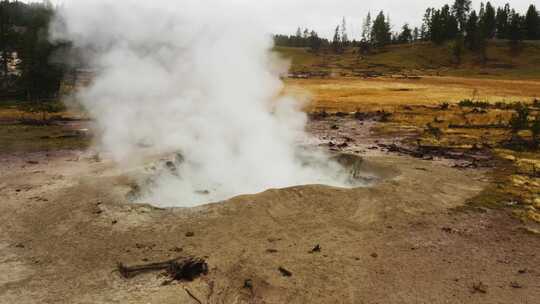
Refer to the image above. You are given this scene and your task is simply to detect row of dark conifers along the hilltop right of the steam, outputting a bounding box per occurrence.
[274,0,540,53]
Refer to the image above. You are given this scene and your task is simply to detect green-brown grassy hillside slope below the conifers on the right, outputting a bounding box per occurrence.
[275,41,540,79]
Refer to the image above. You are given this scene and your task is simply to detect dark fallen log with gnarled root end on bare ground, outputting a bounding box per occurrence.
[117,257,208,281]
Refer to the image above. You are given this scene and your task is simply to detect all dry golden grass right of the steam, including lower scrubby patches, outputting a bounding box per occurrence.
[285,71,540,222]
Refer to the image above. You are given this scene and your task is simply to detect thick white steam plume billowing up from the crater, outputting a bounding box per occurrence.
[53,0,356,206]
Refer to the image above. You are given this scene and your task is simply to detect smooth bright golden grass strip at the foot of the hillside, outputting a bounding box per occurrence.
[285,76,540,111]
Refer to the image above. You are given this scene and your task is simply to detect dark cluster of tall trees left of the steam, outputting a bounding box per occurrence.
[0,0,67,100]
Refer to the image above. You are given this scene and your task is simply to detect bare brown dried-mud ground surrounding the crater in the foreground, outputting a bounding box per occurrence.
[0,124,540,304]
